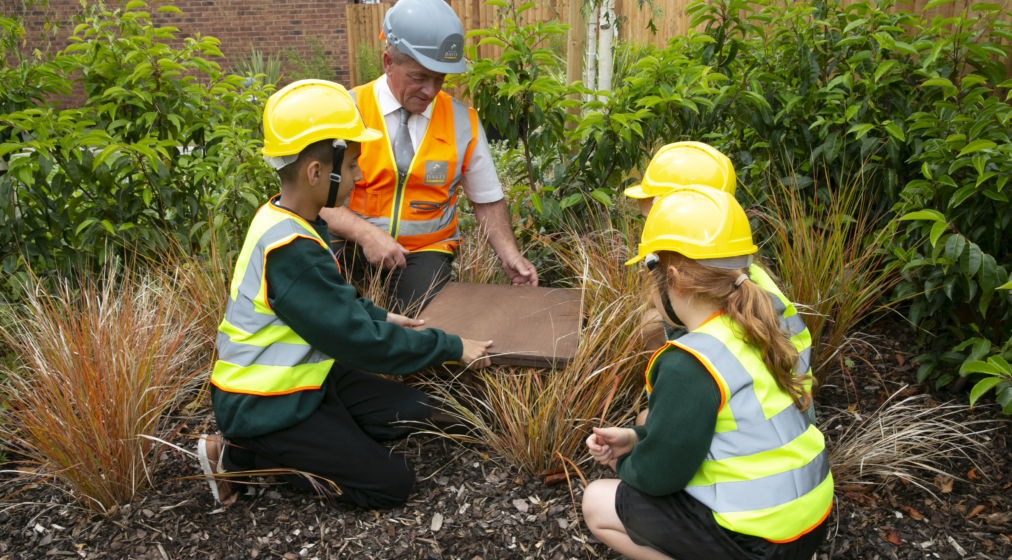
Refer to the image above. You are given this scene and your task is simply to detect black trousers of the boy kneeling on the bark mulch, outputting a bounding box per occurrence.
[224,365,432,509]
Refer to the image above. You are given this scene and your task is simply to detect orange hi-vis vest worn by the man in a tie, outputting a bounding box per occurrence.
[348,78,478,253]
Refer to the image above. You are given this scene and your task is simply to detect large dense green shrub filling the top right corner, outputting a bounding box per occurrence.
[687,0,1012,396]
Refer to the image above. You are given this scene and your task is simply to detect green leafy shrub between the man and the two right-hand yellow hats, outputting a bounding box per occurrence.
[451,0,710,229]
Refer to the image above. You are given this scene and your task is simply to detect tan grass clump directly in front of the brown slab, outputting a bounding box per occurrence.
[427,211,649,475]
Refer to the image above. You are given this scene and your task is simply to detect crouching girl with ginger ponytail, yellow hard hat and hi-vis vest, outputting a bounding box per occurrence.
[583,185,833,560]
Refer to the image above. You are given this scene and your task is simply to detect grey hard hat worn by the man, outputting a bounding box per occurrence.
[383,0,468,74]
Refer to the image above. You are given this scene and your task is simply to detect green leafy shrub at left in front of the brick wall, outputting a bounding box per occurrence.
[0,1,276,290]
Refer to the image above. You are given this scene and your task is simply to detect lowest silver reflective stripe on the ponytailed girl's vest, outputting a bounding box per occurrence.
[685,450,829,513]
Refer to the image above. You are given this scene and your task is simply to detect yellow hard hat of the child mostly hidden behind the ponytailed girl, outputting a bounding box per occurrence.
[625,142,737,198]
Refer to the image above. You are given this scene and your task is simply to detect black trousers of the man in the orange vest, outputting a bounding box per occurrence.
[333,240,453,315]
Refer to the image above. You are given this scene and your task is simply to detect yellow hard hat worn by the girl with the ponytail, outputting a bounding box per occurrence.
[625,184,759,268]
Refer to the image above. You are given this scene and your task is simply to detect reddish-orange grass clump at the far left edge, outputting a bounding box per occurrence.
[0,268,201,512]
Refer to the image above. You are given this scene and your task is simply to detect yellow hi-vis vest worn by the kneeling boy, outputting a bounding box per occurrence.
[210,198,334,396]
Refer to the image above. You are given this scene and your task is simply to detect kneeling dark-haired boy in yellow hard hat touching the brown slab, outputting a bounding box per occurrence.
[197,80,491,508]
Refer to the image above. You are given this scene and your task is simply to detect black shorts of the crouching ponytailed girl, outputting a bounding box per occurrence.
[615,482,829,560]
